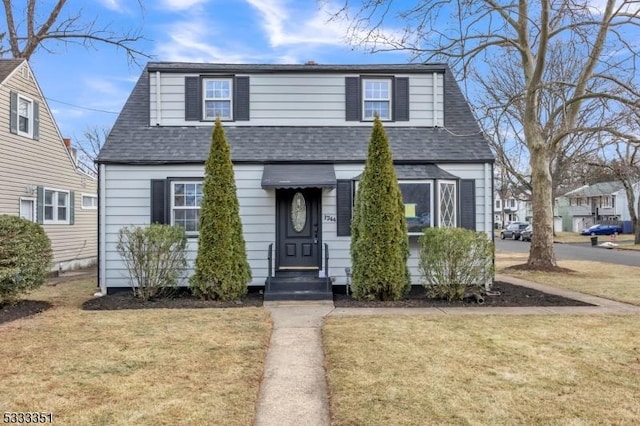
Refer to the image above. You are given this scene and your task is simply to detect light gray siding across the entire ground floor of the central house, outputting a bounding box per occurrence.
[101,164,492,287]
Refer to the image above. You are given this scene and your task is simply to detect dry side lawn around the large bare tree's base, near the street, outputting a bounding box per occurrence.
[496,252,640,305]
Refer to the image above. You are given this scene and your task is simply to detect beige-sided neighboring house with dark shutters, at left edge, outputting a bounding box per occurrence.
[0,59,98,271]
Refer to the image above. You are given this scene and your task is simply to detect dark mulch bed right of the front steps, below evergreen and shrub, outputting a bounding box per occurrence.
[333,282,593,308]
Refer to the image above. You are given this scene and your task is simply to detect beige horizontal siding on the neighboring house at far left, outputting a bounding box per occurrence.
[0,60,98,269]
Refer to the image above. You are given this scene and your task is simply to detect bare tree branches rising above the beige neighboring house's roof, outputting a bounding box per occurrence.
[0,0,150,63]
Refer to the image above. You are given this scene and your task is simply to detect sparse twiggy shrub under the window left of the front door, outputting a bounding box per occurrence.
[116,223,187,300]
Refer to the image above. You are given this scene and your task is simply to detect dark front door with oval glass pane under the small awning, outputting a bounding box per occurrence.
[276,188,322,269]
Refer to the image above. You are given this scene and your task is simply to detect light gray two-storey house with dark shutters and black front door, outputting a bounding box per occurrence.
[97,62,494,292]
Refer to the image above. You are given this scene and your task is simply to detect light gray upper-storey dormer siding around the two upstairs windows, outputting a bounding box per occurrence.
[149,72,444,127]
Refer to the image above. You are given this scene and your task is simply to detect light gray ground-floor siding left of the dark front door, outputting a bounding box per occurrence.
[101,165,276,287]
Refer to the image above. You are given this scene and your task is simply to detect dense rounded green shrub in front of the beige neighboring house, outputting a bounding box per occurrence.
[0,215,52,304]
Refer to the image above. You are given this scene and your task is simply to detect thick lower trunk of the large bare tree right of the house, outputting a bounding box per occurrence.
[527,140,557,269]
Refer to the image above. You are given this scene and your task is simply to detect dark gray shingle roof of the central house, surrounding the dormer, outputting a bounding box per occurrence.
[97,63,494,164]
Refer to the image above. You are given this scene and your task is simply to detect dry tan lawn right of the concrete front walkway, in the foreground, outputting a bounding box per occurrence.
[324,316,640,425]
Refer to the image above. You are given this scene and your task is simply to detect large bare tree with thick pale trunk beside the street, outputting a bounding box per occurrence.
[341,0,640,269]
